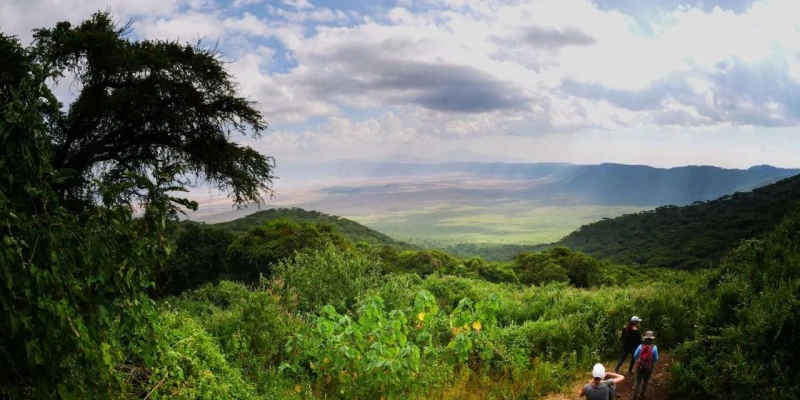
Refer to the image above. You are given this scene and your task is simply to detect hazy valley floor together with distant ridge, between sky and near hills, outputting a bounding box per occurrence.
[181,161,800,250]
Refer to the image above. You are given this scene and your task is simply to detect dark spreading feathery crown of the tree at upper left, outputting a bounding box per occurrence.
[28,13,274,212]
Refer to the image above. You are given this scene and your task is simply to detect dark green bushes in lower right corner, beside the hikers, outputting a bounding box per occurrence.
[676,209,800,399]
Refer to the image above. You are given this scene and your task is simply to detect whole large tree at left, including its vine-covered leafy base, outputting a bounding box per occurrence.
[0,13,273,398]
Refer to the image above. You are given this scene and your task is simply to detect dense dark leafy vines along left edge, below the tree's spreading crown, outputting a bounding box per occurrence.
[0,44,165,398]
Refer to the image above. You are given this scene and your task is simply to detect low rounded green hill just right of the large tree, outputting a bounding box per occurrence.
[214,208,418,250]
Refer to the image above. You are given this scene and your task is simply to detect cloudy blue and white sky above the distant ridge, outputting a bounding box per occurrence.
[0,0,800,170]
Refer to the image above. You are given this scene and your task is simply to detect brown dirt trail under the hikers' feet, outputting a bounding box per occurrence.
[545,352,672,400]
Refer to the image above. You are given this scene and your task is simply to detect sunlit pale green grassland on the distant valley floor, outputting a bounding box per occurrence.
[346,203,643,247]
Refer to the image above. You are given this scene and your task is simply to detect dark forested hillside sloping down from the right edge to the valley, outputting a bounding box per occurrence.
[558,172,800,269]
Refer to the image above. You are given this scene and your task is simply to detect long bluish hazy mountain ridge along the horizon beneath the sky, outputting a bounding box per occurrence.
[277,161,800,207]
